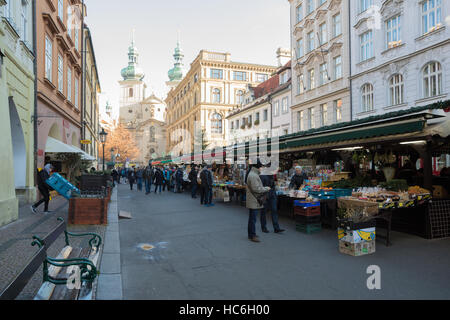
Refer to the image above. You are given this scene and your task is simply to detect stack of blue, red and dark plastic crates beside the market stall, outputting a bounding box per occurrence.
[294,200,322,234]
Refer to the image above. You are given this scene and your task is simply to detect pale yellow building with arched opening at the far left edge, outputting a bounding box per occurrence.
[0,0,36,226]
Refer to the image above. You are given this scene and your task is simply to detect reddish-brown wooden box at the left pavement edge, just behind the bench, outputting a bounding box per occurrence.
[69,198,108,225]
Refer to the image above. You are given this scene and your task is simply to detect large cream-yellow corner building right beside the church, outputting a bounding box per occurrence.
[165,50,277,156]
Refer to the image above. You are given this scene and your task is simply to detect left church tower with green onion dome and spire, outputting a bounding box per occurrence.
[119,31,147,108]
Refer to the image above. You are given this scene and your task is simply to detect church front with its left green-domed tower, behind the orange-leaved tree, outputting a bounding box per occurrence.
[119,39,166,166]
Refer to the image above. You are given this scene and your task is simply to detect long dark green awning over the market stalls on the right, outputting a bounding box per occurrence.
[281,120,425,149]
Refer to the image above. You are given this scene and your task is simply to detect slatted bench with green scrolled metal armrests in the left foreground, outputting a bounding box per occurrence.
[0,217,102,300]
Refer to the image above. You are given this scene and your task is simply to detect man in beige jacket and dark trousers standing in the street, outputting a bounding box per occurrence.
[246,160,270,242]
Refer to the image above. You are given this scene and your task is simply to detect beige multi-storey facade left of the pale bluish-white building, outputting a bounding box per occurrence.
[289,0,351,132]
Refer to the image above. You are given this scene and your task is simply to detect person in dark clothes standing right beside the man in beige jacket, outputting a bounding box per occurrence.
[259,164,285,233]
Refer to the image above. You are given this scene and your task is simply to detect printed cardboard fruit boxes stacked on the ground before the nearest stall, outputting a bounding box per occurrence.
[338,221,375,256]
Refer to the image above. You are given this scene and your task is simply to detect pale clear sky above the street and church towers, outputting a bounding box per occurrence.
[85,0,290,115]
